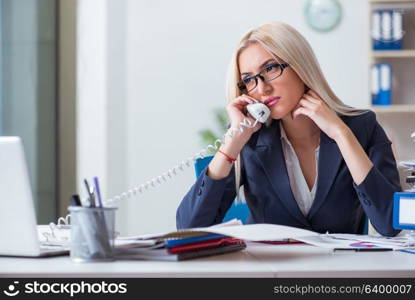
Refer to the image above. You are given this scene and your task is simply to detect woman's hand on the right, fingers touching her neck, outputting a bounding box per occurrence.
[292,90,348,140]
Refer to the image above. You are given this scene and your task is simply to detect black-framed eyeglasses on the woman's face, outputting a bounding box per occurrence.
[238,63,289,93]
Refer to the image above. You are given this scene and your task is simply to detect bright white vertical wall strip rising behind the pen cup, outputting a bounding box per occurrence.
[76,0,109,203]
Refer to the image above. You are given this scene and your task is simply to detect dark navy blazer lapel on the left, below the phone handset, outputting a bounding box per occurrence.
[253,121,309,226]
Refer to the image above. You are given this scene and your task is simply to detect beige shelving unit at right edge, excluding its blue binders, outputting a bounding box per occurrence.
[366,0,415,177]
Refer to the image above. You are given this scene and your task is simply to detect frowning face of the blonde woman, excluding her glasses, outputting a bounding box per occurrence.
[238,43,304,119]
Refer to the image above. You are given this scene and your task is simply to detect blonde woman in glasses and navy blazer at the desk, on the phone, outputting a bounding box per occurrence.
[177,22,401,236]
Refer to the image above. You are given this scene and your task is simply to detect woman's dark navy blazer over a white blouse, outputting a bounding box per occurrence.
[176,111,401,236]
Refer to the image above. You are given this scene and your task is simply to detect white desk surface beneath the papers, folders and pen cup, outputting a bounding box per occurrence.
[0,243,415,277]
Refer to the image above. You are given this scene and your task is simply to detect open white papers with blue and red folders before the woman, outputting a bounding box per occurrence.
[117,221,318,260]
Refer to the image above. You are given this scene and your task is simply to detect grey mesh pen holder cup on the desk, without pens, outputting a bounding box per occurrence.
[68,206,117,262]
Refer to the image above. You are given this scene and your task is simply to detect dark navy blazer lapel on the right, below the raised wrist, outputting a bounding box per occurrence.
[308,132,343,218]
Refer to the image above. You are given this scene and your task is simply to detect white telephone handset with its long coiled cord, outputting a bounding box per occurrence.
[105,102,271,205]
